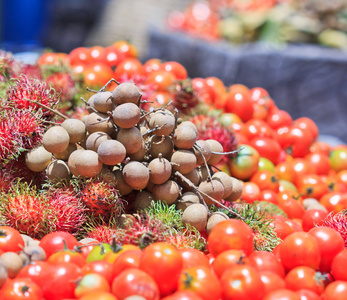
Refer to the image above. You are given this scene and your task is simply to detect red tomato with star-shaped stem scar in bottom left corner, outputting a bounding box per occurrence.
[0,278,44,300]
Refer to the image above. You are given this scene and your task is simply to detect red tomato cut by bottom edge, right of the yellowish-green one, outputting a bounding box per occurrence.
[111,268,160,300]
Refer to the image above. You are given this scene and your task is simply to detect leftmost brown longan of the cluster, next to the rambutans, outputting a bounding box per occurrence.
[25,146,53,172]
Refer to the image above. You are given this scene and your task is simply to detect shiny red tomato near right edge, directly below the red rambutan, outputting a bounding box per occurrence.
[308,226,347,279]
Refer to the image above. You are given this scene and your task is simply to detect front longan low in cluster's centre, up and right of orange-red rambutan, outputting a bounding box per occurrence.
[122,161,149,190]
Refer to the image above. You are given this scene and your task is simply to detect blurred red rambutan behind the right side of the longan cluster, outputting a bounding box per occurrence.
[189,115,237,162]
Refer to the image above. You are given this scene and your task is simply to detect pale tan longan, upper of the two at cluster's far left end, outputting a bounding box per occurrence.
[42,126,70,153]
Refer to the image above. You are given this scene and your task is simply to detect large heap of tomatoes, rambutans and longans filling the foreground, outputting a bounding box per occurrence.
[0,41,347,300]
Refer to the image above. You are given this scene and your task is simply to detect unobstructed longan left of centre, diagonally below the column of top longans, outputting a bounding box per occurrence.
[97,140,126,166]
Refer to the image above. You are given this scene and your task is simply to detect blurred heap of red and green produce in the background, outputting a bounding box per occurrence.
[167,0,347,49]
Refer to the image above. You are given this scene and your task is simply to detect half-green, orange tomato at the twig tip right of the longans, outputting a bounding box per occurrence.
[228,144,260,180]
